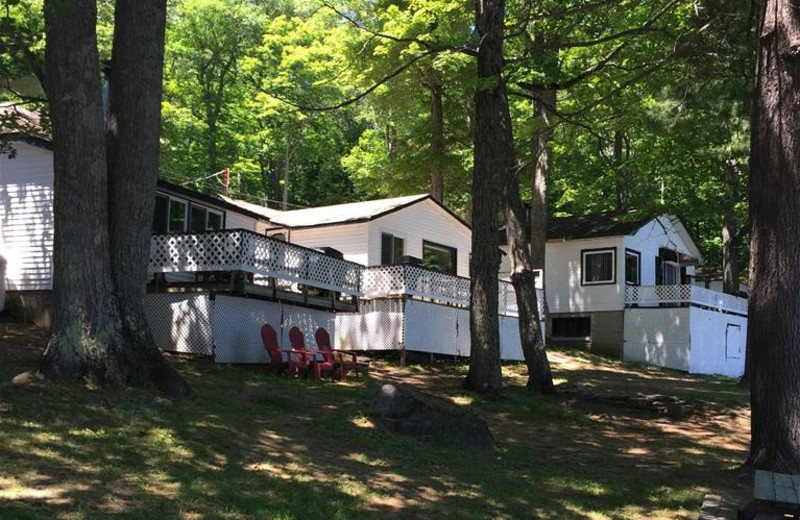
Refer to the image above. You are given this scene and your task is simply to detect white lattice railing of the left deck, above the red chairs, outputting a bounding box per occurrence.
[149,229,364,295]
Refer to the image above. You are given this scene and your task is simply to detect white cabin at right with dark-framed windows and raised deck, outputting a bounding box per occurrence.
[501,213,747,376]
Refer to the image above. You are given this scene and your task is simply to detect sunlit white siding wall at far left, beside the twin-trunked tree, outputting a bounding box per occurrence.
[0,142,53,290]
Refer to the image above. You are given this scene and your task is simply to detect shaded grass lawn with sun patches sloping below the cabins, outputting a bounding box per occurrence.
[0,324,752,520]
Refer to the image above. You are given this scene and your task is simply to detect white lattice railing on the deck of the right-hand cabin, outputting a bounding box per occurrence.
[625,285,747,316]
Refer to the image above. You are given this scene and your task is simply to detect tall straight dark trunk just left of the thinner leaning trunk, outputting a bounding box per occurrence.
[464,0,504,396]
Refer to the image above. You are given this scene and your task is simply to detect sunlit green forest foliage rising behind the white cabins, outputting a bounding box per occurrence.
[0,0,753,264]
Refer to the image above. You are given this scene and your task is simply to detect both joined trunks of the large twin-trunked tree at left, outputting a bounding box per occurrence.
[42,0,188,394]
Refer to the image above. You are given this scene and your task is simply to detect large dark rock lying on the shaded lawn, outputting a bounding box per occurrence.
[369,384,494,449]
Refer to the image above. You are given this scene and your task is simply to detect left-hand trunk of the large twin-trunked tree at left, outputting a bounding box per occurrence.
[41,0,122,383]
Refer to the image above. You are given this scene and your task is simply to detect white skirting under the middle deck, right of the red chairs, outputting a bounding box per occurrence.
[336,298,544,361]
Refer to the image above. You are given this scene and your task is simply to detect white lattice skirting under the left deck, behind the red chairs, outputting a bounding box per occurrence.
[147,294,335,363]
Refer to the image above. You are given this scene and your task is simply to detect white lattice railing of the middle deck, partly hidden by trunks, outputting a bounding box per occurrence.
[361,265,544,317]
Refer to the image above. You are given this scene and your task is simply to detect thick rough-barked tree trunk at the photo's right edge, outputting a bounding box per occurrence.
[747,0,800,474]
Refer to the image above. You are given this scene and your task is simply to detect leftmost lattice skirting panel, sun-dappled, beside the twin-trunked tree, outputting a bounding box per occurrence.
[145,293,214,356]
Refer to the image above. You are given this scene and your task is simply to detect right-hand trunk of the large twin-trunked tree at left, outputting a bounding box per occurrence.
[108,0,188,393]
